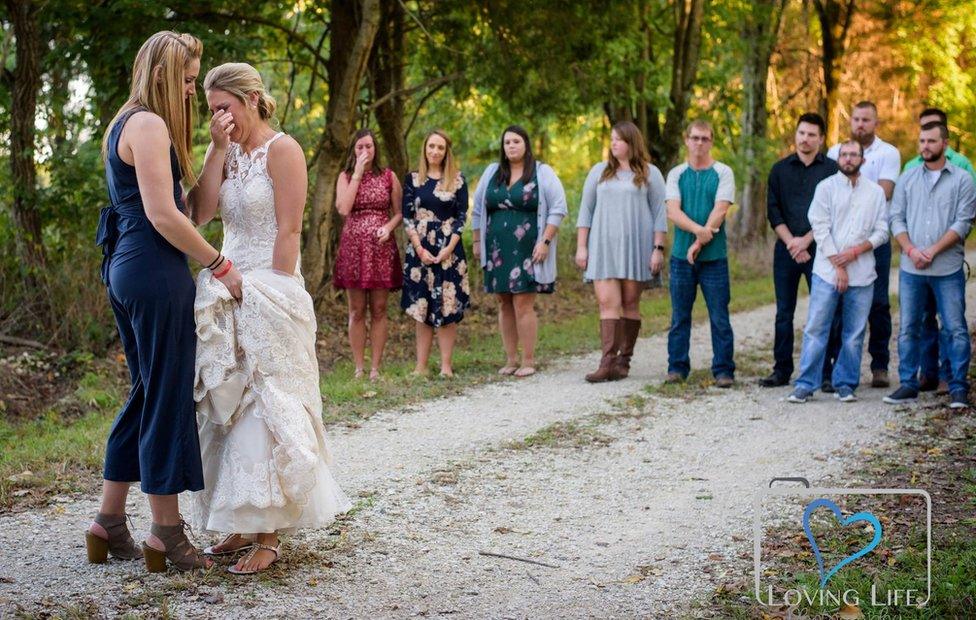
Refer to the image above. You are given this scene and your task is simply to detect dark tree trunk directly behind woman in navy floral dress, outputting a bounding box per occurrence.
[369,0,410,178]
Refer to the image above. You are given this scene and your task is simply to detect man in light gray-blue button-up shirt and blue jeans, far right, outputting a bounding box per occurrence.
[884,123,976,409]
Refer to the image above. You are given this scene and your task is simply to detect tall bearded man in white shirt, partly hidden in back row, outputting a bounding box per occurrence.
[824,101,901,387]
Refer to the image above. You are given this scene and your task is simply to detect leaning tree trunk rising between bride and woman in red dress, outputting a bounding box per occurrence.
[302,0,380,302]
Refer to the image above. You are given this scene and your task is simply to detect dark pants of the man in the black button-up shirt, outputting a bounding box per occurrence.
[773,241,816,379]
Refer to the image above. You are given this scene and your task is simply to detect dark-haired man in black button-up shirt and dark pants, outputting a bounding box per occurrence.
[759,113,838,387]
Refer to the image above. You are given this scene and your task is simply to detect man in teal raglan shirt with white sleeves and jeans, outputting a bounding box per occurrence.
[665,120,735,388]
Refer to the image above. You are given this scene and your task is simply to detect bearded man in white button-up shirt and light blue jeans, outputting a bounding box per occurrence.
[787,140,888,403]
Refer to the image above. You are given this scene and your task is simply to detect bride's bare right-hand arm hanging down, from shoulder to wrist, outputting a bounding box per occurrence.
[268,136,308,274]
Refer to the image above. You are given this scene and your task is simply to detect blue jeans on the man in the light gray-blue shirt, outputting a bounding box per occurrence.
[898,269,972,392]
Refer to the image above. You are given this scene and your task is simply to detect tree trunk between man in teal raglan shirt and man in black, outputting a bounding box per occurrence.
[729,0,785,247]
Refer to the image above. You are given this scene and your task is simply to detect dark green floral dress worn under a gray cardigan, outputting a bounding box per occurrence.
[485,175,555,293]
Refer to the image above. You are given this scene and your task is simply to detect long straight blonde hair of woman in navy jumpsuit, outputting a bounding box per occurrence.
[102,30,203,185]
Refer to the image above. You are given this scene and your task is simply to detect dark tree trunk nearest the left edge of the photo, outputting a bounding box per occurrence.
[5,0,45,272]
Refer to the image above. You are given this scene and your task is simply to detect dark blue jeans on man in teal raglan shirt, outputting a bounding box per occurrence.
[668,258,735,377]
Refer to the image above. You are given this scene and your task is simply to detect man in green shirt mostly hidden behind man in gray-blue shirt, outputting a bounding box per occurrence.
[902,108,976,394]
